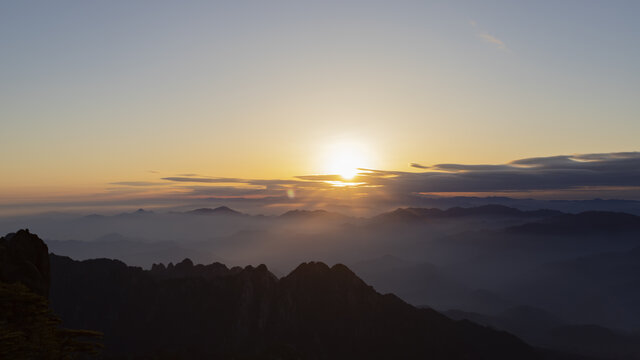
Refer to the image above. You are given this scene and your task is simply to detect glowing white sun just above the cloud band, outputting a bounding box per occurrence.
[324,141,369,180]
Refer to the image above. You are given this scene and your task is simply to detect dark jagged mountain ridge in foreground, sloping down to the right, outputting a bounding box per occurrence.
[45,254,537,359]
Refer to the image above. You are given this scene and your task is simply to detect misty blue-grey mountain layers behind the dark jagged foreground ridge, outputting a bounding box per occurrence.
[0,205,640,359]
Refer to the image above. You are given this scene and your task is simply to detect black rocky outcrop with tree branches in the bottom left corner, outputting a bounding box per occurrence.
[0,230,102,360]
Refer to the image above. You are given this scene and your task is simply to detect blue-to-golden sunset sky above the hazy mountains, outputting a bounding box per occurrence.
[0,1,640,212]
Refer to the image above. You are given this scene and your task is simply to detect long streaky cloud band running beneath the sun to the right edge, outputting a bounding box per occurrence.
[107,152,640,203]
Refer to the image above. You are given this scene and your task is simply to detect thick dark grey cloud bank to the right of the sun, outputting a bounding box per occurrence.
[362,152,640,195]
